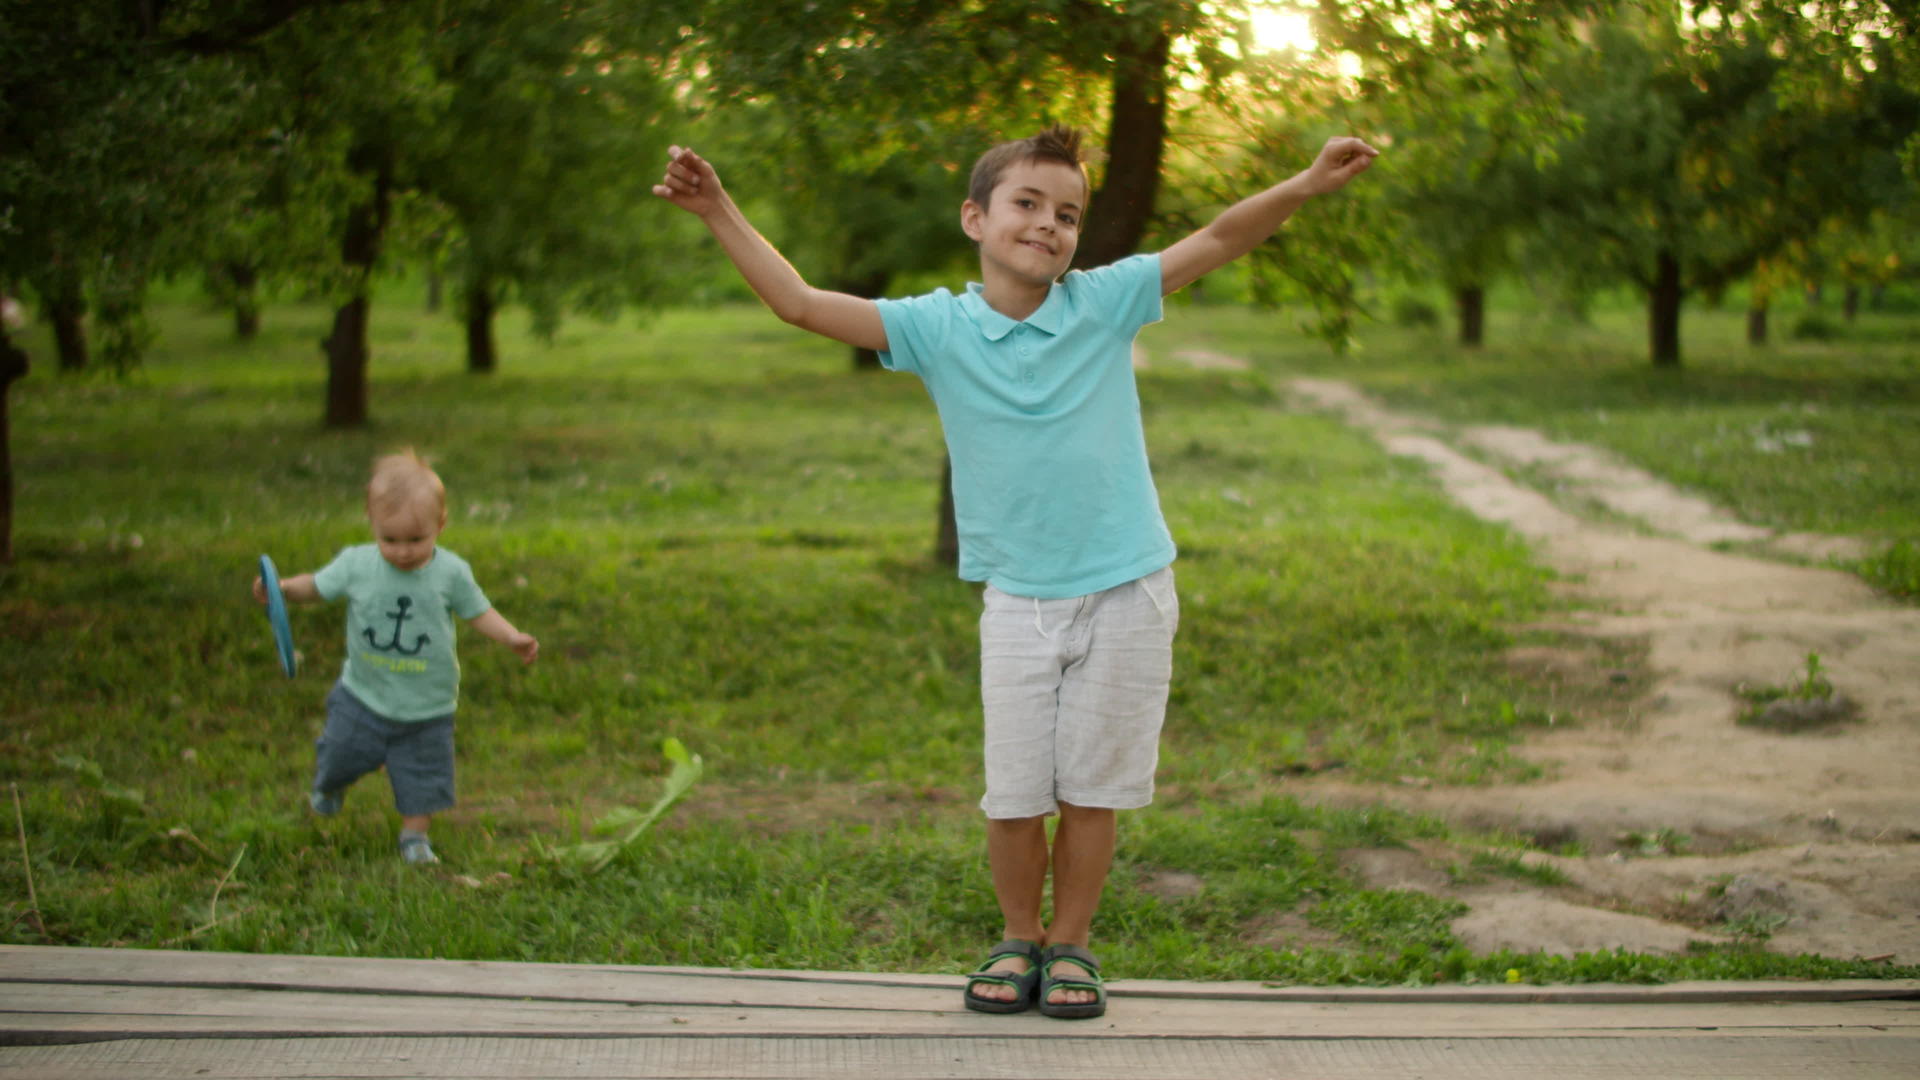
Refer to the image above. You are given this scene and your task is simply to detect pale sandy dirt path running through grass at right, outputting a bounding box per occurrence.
[1288,379,1920,965]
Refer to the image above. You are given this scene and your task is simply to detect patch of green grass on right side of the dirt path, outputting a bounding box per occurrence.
[1171,286,1920,572]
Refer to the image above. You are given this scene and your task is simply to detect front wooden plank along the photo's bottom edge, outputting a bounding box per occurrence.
[0,1034,1920,1080]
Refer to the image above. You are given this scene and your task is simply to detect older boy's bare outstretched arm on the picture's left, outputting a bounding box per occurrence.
[653,146,887,352]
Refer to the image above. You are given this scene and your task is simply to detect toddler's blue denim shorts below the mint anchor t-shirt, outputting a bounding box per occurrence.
[313,682,453,817]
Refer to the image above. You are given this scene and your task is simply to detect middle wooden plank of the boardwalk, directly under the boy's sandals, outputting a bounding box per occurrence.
[0,984,1920,1043]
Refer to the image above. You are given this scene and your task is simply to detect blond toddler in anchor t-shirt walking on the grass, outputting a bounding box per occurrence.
[253,450,540,865]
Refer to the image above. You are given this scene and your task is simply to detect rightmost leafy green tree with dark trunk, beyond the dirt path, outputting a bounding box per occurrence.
[1530,6,1912,367]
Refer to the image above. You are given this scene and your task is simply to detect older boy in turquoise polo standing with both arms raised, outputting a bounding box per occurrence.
[653,129,1377,1017]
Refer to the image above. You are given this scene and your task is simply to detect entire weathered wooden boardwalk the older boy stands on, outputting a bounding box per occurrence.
[0,945,1920,1080]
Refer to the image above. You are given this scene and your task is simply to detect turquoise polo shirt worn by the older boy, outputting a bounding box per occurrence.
[877,256,1173,600]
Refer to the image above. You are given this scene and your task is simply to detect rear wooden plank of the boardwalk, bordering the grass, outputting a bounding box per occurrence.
[0,945,1920,1009]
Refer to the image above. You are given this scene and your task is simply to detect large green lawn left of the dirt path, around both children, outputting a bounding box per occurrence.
[0,286,1907,982]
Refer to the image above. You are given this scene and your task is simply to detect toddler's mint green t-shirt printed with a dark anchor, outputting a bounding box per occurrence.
[313,544,492,721]
